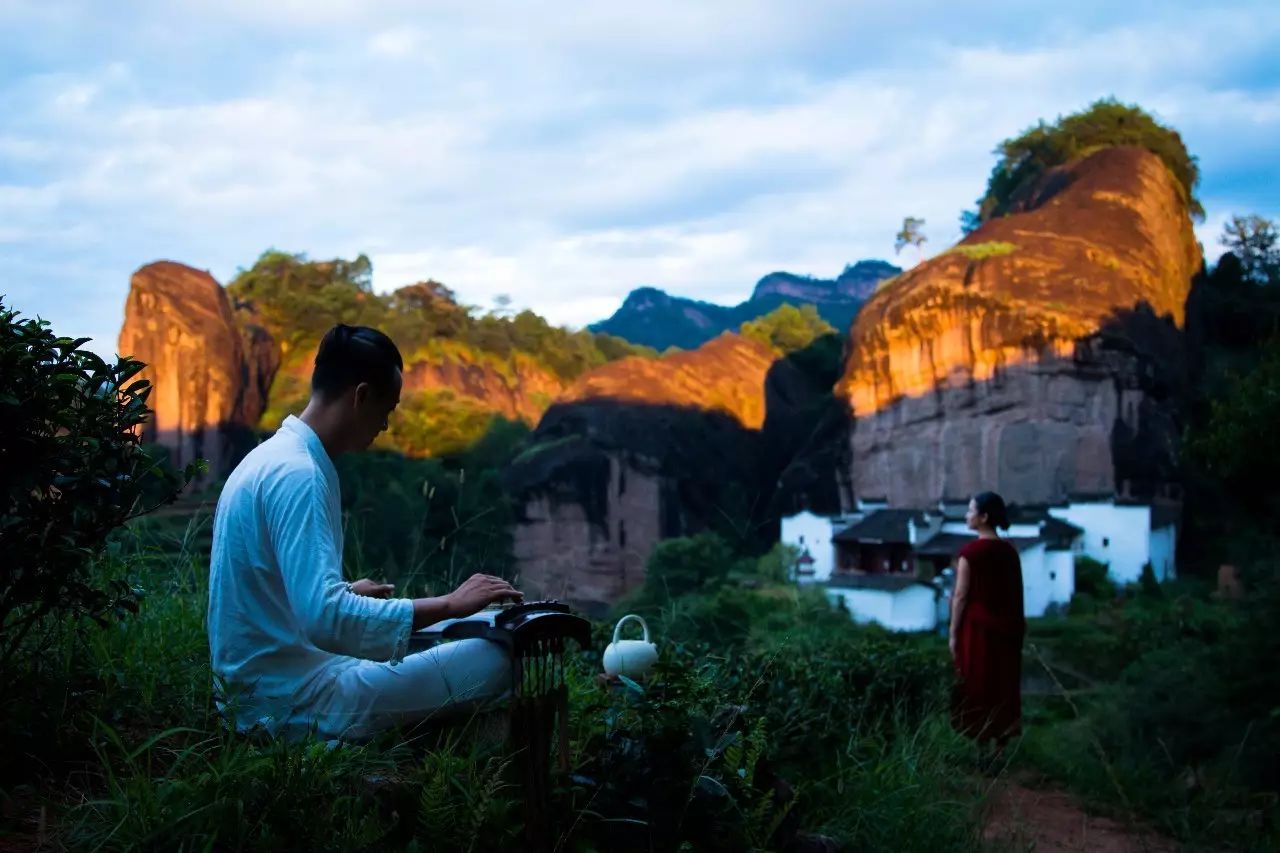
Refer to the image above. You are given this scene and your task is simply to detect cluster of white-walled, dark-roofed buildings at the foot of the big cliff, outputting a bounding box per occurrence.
[782,497,1178,630]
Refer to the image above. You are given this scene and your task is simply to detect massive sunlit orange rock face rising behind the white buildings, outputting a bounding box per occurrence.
[837,147,1201,505]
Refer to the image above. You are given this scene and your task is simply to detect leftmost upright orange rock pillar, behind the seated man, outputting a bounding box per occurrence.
[119,261,278,475]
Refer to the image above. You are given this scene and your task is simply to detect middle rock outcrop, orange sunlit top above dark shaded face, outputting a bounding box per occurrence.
[507,334,777,612]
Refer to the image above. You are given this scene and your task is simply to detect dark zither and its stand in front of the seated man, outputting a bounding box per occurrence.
[410,601,591,850]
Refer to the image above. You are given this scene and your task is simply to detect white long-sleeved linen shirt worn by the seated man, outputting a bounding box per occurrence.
[209,415,413,731]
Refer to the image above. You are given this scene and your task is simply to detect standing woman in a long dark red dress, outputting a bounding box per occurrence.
[951,492,1027,749]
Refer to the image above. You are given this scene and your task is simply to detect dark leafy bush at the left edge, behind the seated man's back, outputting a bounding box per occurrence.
[0,302,204,692]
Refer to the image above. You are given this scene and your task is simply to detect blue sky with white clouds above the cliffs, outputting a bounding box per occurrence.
[0,0,1280,353]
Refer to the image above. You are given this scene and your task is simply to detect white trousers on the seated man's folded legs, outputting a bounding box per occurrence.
[287,639,511,740]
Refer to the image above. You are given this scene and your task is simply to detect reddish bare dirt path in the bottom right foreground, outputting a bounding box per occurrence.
[983,777,1178,853]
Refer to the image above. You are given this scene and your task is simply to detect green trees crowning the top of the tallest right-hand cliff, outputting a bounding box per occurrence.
[978,97,1204,222]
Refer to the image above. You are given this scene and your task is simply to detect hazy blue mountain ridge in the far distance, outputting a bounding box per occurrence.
[590,260,902,350]
